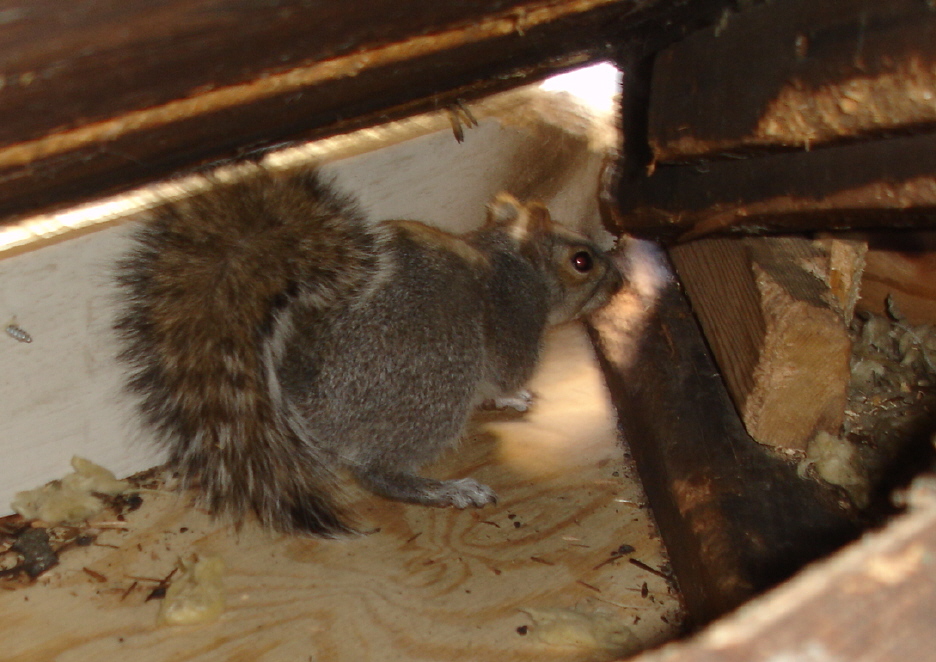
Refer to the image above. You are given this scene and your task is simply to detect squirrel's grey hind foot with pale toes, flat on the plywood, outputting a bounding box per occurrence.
[356,470,497,508]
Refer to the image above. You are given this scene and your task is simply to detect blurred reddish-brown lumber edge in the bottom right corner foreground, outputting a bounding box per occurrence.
[635,477,936,662]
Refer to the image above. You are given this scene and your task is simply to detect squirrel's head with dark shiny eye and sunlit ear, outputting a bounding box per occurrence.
[487,193,624,324]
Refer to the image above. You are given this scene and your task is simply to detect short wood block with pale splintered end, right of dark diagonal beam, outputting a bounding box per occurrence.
[672,237,863,450]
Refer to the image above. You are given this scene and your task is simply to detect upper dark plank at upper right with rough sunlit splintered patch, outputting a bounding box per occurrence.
[649,0,936,163]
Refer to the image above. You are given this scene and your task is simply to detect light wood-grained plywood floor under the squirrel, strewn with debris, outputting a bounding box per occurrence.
[0,326,680,662]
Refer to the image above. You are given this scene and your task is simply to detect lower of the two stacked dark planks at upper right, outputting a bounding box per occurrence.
[615,134,936,238]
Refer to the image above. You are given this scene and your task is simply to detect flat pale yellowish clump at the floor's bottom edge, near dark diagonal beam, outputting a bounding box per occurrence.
[520,607,642,659]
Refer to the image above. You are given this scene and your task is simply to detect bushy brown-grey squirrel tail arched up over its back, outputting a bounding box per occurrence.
[116,167,380,535]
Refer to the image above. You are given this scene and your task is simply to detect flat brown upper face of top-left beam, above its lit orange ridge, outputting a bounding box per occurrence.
[0,0,548,145]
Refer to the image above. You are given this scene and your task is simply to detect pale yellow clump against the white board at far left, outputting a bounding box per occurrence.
[11,455,130,525]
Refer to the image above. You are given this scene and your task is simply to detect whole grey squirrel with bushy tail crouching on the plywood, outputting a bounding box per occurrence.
[115,164,624,537]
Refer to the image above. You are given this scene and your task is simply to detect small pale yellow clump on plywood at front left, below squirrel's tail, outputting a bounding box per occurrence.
[156,556,224,625]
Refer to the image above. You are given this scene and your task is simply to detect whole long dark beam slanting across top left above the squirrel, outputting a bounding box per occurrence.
[0,0,744,223]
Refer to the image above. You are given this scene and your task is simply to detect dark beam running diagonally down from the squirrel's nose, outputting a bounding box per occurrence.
[591,284,856,625]
